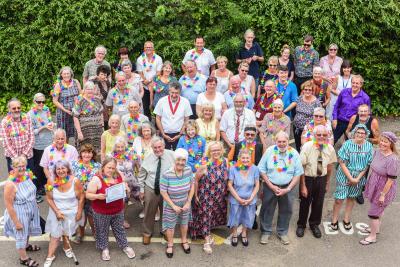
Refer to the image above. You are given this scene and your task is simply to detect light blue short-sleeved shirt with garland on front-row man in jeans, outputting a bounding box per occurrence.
[258,145,304,185]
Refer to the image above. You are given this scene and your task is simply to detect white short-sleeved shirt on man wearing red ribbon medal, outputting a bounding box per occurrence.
[154,96,193,134]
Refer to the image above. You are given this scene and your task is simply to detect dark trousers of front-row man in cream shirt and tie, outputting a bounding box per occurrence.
[297,176,326,228]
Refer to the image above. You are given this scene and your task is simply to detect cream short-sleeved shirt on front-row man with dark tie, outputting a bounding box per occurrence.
[300,141,337,177]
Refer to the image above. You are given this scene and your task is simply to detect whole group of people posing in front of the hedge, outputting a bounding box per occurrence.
[0,30,399,267]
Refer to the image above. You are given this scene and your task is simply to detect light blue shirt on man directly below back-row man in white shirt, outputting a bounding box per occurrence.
[179,73,207,105]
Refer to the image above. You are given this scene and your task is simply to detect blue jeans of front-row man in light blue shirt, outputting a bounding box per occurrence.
[260,184,294,236]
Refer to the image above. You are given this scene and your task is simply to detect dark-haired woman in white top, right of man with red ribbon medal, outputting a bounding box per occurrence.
[196,77,227,120]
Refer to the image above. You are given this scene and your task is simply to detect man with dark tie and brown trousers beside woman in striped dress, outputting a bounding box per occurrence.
[138,136,175,245]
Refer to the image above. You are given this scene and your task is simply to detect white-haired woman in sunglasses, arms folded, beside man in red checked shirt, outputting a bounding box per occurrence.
[28,93,54,201]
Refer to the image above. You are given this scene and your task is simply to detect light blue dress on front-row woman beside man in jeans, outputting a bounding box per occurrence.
[228,165,260,229]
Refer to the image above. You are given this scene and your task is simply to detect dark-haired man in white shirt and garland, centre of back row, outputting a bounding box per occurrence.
[182,36,217,77]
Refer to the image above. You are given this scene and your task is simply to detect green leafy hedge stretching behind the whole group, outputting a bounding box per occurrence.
[0,0,400,115]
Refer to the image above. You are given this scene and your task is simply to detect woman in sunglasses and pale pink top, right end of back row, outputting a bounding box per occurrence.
[319,43,343,84]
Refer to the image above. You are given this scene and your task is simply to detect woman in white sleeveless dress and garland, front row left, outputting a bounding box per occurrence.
[44,160,85,267]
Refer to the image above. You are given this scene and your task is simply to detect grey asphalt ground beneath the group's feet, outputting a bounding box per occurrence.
[0,116,400,267]
